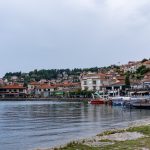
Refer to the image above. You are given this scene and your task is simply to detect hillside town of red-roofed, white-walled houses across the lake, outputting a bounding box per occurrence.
[0,59,150,98]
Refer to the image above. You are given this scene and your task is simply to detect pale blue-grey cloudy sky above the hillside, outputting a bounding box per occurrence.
[0,0,150,76]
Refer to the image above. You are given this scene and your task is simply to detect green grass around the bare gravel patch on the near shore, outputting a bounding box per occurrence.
[54,126,150,150]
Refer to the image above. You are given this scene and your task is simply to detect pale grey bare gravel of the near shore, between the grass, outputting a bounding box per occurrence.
[36,119,150,150]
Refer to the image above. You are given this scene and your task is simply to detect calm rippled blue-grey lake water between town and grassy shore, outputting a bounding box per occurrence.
[0,101,150,150]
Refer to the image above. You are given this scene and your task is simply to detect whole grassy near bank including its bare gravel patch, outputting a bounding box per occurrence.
[49,125,150,150]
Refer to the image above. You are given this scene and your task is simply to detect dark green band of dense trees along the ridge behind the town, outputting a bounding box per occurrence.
[4,67,99,82]
